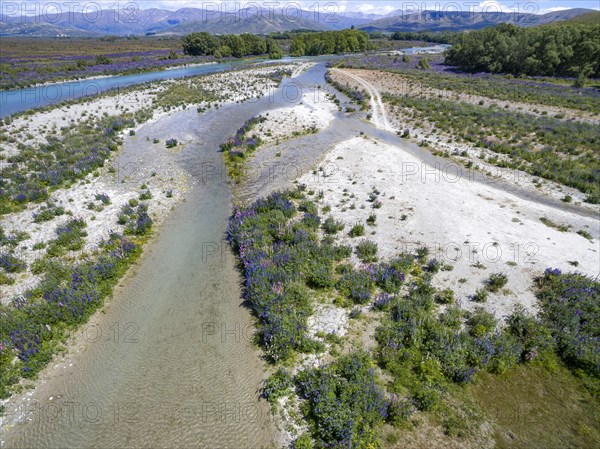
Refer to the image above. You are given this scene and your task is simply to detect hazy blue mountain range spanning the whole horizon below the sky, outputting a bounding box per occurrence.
[0,8,594,37]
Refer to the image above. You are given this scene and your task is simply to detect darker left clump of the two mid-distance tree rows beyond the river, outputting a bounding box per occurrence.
[182,32,283,59]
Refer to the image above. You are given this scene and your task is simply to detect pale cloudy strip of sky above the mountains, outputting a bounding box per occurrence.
[0,0,600,14]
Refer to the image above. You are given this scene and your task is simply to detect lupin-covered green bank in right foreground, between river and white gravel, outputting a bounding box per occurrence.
[228,187,600,448]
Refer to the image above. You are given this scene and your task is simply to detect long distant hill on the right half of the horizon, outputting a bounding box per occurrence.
[360,8,592,32]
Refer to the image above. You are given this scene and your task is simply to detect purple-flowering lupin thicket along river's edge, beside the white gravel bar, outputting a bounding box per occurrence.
[227,192,326,361]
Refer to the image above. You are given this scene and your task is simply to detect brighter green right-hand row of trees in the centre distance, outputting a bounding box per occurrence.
[290,30,371,56]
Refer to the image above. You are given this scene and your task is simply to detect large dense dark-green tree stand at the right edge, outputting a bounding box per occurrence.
[446,24,600,81]
